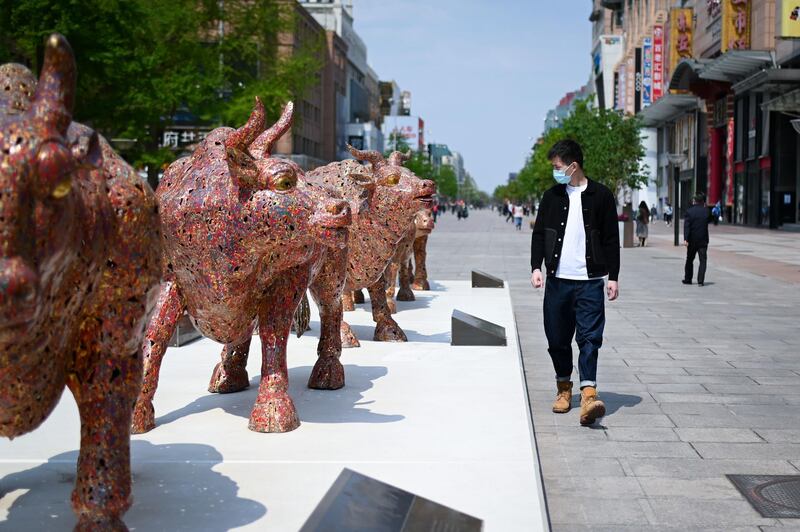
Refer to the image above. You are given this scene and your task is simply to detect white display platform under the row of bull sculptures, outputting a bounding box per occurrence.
[0,282,547,532]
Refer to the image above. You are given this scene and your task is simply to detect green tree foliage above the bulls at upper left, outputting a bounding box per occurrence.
[0,0,324,186]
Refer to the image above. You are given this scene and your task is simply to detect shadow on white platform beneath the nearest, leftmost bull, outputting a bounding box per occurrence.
[0,440,267,531]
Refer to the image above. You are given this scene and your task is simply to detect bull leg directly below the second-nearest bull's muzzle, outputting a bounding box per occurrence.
[308,250,347,390]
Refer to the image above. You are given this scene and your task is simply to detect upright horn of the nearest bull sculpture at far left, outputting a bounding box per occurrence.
[29,33,76,135]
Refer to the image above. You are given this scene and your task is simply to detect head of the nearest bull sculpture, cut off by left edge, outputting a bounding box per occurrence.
[0,34,102,332]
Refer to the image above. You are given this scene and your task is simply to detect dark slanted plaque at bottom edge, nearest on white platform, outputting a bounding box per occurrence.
[300,469,483,532]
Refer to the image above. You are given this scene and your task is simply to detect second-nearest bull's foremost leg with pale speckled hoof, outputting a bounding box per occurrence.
[247,268,308,432]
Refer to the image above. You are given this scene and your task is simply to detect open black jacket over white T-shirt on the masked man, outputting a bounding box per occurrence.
[531,179,619,281]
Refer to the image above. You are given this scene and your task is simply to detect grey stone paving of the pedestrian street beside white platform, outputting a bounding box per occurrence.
[428,211,800,531]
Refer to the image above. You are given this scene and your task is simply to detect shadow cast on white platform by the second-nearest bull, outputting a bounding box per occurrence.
[156,364,405,427]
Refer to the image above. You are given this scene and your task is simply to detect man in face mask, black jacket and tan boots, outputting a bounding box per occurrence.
[531,140,619,425]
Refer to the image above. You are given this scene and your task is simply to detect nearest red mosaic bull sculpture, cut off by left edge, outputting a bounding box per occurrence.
[0,35,160,530]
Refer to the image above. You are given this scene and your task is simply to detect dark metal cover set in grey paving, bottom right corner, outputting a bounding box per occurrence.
[727,475,800,519]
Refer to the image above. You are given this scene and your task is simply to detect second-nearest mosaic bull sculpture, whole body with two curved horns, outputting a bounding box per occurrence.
[133,99,351,433]
